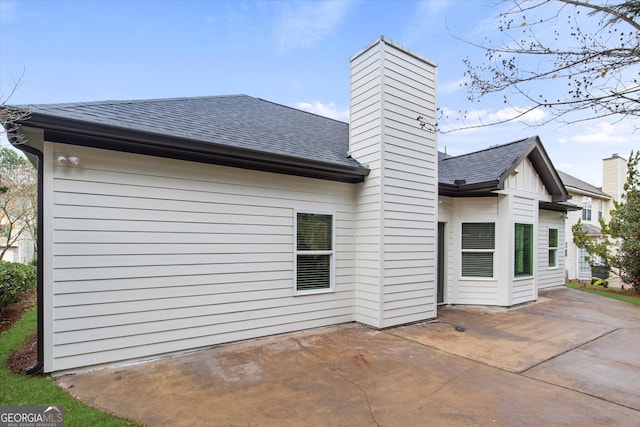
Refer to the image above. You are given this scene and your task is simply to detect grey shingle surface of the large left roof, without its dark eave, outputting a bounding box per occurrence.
[22,95,359,167]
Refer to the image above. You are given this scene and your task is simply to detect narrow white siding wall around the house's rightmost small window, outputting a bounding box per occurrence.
[536,211,565,289]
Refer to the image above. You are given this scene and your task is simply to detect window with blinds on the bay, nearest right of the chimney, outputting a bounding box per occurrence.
[462,222,496,277]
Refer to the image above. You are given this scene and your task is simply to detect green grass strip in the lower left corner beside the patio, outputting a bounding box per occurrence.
[0,308,140,427]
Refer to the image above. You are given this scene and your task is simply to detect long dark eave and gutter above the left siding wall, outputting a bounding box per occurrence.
[19,112,369,183]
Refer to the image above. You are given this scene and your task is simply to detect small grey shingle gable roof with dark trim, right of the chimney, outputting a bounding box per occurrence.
[438,136,568,203]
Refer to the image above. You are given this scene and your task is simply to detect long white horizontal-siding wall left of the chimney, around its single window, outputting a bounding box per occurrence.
[45,143,354,371]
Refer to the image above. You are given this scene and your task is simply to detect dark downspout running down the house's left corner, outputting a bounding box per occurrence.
[7,135,44,375]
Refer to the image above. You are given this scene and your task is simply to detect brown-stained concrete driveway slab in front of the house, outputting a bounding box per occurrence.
[57,288,640,426]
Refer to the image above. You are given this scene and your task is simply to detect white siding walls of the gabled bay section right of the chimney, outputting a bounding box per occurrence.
[439,159,565,306]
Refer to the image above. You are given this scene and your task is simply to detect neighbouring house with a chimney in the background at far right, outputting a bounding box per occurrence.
[558,154,627,281]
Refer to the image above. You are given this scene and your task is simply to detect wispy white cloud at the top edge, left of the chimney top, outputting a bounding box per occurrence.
[276,0,352,52]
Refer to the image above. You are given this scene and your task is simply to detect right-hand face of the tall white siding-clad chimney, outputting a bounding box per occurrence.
[381,40,438,326]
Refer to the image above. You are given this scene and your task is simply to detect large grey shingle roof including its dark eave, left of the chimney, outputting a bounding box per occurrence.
[11,95,368,182]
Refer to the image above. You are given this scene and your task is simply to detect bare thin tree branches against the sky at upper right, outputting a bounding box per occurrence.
[458,0,640,129]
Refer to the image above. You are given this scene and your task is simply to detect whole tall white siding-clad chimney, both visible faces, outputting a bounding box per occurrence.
[350,38,438,327]
